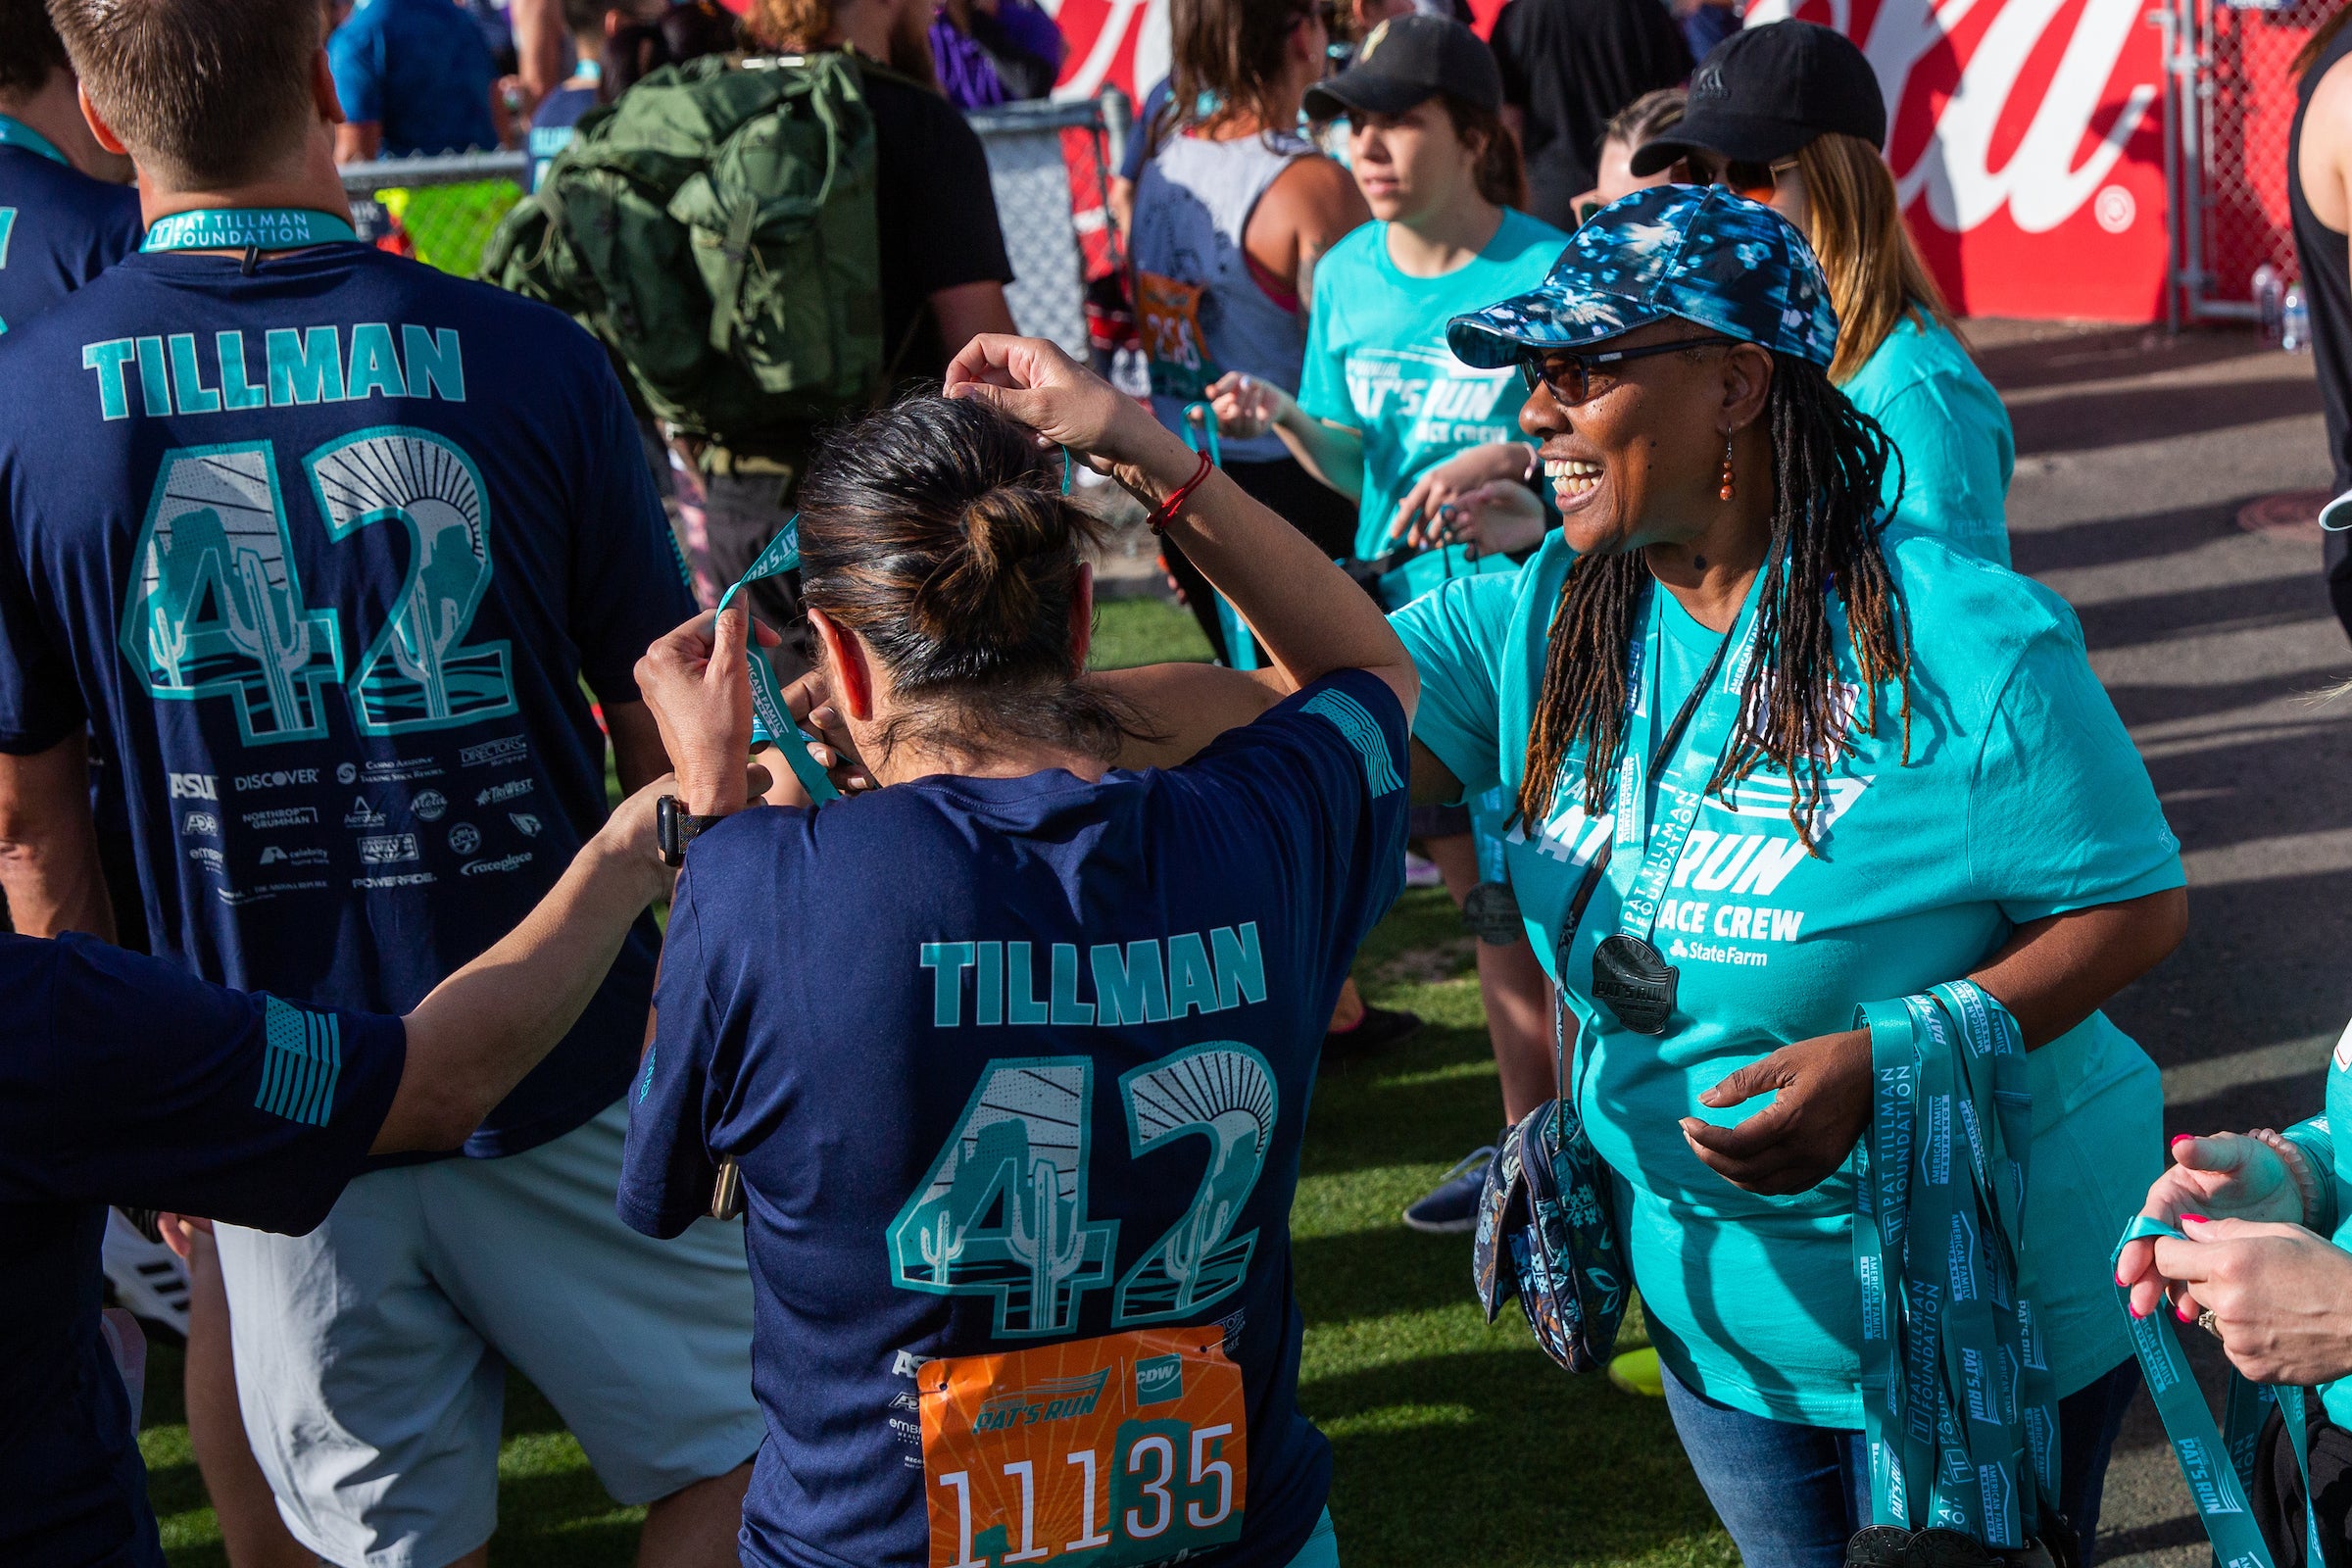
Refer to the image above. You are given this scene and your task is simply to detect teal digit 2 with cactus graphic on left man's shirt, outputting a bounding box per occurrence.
[304,425,515,736]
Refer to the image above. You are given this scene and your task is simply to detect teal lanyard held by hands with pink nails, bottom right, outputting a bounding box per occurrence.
[2115,1215,2327,1568]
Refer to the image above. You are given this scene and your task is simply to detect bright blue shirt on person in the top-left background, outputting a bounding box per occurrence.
[327,0,499,158]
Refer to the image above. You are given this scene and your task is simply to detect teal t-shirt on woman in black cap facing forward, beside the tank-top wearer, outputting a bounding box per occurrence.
[1298,207,1569,607]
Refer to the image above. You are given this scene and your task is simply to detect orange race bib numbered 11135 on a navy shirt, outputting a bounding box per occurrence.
[915,1324,1249,1568]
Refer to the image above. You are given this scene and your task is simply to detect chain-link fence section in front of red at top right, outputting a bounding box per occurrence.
[2157,0,2338,322]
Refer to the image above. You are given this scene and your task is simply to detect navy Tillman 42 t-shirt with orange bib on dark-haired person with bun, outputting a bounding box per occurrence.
[621,670,1406,1568]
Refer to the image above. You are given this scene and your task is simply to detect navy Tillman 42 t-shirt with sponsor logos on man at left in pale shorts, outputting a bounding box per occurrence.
[0,239,694,1156]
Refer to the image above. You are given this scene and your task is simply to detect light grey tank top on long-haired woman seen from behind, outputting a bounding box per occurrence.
[1134,134,1315,464]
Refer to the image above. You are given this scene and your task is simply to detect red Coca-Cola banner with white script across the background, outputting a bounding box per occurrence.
[1049,0,2166,322]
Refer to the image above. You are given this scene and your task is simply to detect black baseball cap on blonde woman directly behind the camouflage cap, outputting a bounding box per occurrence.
[1633,22,1886,174]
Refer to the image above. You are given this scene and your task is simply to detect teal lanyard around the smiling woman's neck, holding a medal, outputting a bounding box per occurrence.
[1609,575,1771,943]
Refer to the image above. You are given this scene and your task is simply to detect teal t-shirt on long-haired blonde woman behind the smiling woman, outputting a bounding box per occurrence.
[1841,311,2018,566]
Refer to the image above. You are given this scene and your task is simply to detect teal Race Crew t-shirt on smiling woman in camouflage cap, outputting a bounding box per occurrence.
[1393,531,2182,1427]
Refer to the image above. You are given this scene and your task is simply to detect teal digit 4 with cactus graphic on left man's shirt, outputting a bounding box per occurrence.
[120,442,343,745]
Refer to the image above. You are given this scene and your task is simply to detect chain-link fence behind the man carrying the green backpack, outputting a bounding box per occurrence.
[343,99,1124,360]
